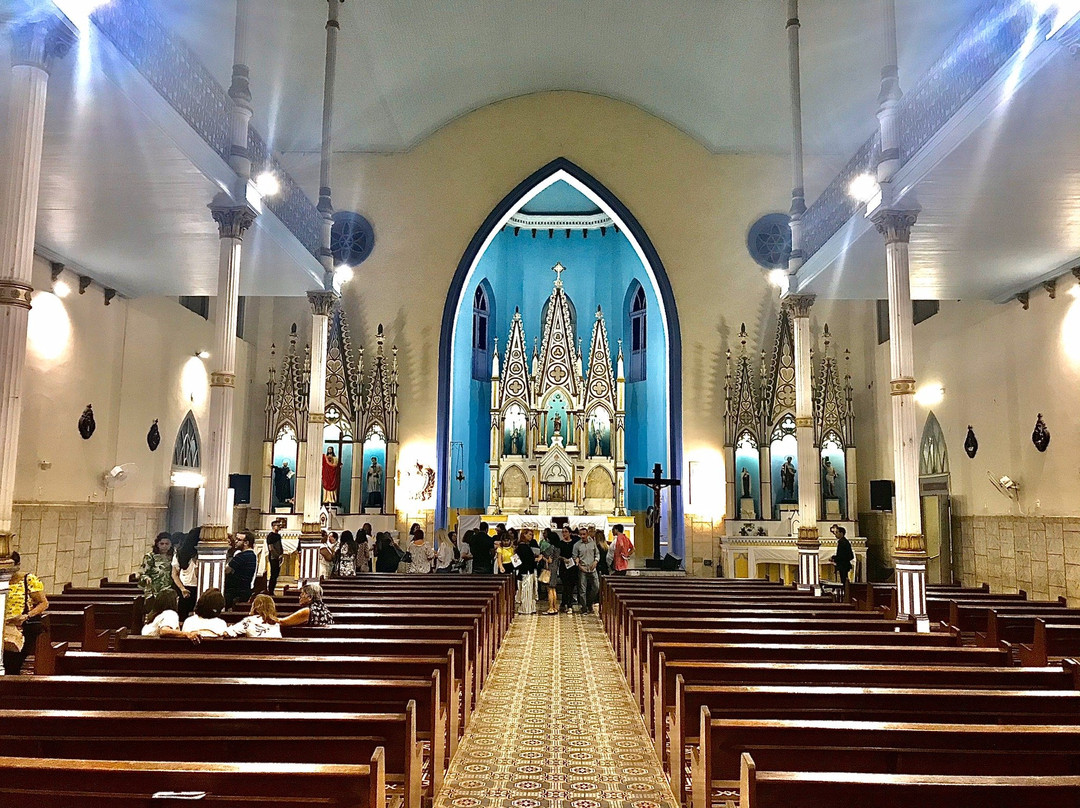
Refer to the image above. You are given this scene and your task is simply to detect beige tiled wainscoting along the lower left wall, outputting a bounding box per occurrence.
[12,502,165,592]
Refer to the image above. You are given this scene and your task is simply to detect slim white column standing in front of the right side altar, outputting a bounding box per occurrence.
[785,295,821,590]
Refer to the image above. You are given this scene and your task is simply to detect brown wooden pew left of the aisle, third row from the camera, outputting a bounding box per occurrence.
[0,672,449,792]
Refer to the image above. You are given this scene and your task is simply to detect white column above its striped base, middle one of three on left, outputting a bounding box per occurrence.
[202,206,255,541]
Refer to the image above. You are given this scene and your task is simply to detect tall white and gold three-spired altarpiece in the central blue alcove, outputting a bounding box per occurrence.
[488,264,626,516]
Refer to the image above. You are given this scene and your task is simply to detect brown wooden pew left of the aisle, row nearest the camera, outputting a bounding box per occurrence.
[0,750,387,808]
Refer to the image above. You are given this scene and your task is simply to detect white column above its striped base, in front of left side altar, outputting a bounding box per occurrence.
[300,292,338,535]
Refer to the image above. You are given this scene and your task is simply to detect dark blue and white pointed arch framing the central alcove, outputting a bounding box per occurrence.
[435,158,684,555]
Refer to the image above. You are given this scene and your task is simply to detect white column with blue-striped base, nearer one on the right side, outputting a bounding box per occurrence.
[873,210,930,631]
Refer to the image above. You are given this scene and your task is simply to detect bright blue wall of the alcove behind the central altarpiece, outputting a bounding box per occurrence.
[449,228,669,510]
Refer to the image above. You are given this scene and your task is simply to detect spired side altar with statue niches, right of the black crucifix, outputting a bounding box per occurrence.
[721,305,866,583]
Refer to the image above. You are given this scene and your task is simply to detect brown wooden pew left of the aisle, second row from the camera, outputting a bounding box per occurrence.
[0,701,422,808]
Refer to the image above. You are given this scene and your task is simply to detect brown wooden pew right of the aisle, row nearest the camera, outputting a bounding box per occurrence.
[739,754,1080,808]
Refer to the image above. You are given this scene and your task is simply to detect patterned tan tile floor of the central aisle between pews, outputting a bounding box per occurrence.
[435,615,675,808]
